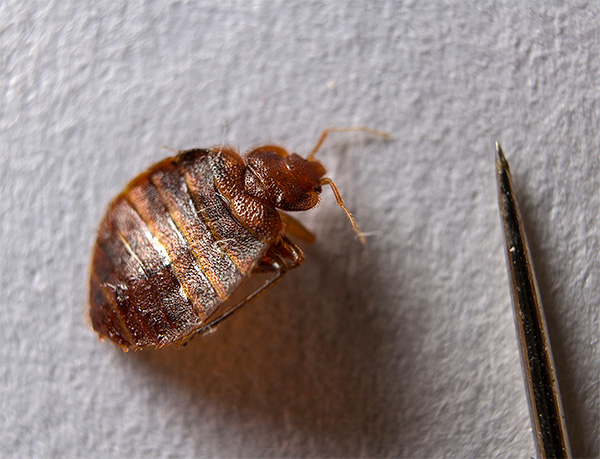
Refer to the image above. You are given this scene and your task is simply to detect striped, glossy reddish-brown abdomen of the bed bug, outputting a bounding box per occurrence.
[90,150,268,349]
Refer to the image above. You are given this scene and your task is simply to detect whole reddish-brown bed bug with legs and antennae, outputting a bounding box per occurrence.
[89,127,389,351]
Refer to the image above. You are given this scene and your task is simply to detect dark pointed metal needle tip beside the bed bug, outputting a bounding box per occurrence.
[496,143,571,458]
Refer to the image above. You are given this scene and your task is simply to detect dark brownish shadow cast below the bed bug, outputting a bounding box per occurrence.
[133,230,410,456]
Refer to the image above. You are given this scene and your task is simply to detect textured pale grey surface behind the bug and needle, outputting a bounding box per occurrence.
[0,0,600,457]
